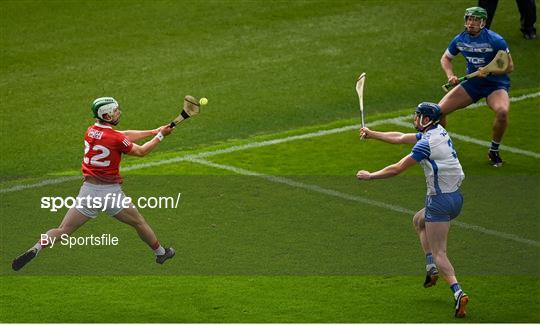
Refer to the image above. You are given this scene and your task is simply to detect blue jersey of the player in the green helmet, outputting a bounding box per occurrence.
[445,28,510,86]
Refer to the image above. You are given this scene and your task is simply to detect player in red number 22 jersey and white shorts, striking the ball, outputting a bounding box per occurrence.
[12,97,174,271]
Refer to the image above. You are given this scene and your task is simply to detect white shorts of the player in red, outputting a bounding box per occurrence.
[75,182,133,218]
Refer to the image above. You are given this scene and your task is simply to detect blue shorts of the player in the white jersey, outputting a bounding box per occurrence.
[425,190,463,222]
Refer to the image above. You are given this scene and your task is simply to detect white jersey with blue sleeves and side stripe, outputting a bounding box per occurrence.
[411,125,465,195]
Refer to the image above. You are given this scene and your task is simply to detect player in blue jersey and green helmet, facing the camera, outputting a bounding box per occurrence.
[439,7,514,167]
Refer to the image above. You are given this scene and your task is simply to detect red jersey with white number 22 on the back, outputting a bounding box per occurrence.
[82,123,133,183]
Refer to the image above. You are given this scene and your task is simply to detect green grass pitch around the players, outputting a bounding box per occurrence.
[0,0,540,323]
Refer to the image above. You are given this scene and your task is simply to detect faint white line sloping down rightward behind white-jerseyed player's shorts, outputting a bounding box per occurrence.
[189,158,540,247]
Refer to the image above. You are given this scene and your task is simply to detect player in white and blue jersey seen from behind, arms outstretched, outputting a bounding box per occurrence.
[356,103,469,317]
